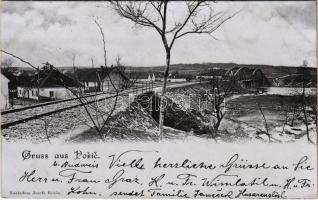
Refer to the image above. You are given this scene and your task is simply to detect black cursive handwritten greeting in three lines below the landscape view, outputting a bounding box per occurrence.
[12,149,316,199]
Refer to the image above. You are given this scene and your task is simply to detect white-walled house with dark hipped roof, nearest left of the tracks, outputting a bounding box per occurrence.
[17,64,82,101]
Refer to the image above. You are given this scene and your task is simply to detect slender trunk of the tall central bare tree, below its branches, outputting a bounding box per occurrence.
[159,51,170,139]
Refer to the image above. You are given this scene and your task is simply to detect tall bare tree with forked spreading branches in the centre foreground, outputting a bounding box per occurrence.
[111,1,236,137]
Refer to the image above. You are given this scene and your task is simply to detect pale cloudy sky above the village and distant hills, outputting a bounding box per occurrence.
[1,1,316,66]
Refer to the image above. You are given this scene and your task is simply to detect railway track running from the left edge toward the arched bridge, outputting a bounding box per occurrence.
[1,83,196,129]
